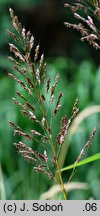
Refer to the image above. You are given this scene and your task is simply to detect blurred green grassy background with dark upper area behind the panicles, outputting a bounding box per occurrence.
[0,0,100,199]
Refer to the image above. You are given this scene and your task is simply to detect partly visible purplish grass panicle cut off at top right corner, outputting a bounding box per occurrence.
[64,0,100,50]
